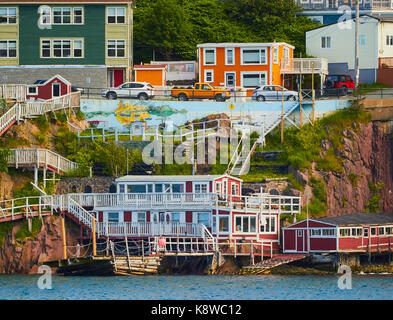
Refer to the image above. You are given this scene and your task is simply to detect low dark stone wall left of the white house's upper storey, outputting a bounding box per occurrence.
[55,177,116,194]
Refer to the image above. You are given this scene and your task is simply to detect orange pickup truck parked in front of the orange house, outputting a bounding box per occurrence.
[171,83,231,101]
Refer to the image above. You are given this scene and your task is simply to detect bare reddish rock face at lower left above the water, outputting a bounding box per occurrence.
[0,216,78,274]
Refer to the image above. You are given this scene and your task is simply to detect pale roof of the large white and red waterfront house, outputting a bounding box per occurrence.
[116,175,242,182]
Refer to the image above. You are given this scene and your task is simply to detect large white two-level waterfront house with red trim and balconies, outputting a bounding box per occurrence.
[69,175,301,252]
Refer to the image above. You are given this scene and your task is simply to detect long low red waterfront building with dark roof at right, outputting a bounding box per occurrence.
[282,213,393,253]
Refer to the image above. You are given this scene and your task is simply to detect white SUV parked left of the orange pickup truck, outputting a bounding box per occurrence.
[101,82,154,100]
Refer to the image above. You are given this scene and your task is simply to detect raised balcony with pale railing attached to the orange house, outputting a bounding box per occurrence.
[281,58,329,75]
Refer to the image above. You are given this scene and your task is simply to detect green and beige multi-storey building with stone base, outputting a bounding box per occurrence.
[0,0,133,88]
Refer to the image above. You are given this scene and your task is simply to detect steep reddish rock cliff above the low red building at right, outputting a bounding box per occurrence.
[313,122,393,216]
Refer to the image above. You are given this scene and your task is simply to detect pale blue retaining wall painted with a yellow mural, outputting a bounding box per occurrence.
[81,99,348,130]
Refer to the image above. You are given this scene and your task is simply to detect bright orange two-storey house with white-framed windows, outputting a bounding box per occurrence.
[198,42,295,90]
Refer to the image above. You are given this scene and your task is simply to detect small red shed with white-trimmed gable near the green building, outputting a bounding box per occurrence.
[26,75,71,100]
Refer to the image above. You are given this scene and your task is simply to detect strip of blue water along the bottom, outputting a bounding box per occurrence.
[0,275,393,300]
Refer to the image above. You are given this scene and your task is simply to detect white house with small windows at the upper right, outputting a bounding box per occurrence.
[306,15,393,83]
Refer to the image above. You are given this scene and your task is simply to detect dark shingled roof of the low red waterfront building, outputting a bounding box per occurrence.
[314,213,393,226]
